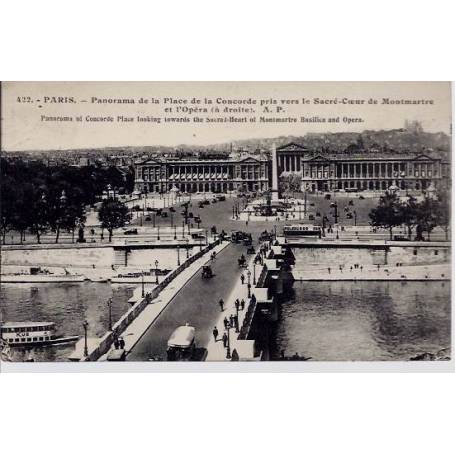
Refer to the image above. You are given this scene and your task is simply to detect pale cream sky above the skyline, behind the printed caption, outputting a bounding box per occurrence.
[1,82,451,151]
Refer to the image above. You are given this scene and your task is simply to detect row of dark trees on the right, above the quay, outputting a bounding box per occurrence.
[369,191,450,240]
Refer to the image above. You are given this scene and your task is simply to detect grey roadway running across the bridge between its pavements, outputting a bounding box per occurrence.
[127,244,244,361]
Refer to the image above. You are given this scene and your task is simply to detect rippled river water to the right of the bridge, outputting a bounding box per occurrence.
[272,281,451,361]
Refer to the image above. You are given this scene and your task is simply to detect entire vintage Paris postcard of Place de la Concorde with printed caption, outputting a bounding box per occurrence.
[0,82,452,371]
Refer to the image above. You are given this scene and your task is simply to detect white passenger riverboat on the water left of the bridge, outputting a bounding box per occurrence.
[0,321,79,347]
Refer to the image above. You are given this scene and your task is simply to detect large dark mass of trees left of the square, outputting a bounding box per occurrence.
[0,158,131,244]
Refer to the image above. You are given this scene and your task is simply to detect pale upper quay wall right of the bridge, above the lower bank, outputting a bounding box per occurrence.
[292,245,450,270]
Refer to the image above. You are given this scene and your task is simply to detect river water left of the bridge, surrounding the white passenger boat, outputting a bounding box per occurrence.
[0,282,135,361]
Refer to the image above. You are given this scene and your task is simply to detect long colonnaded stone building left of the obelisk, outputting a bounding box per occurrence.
[135,156,271,193]
